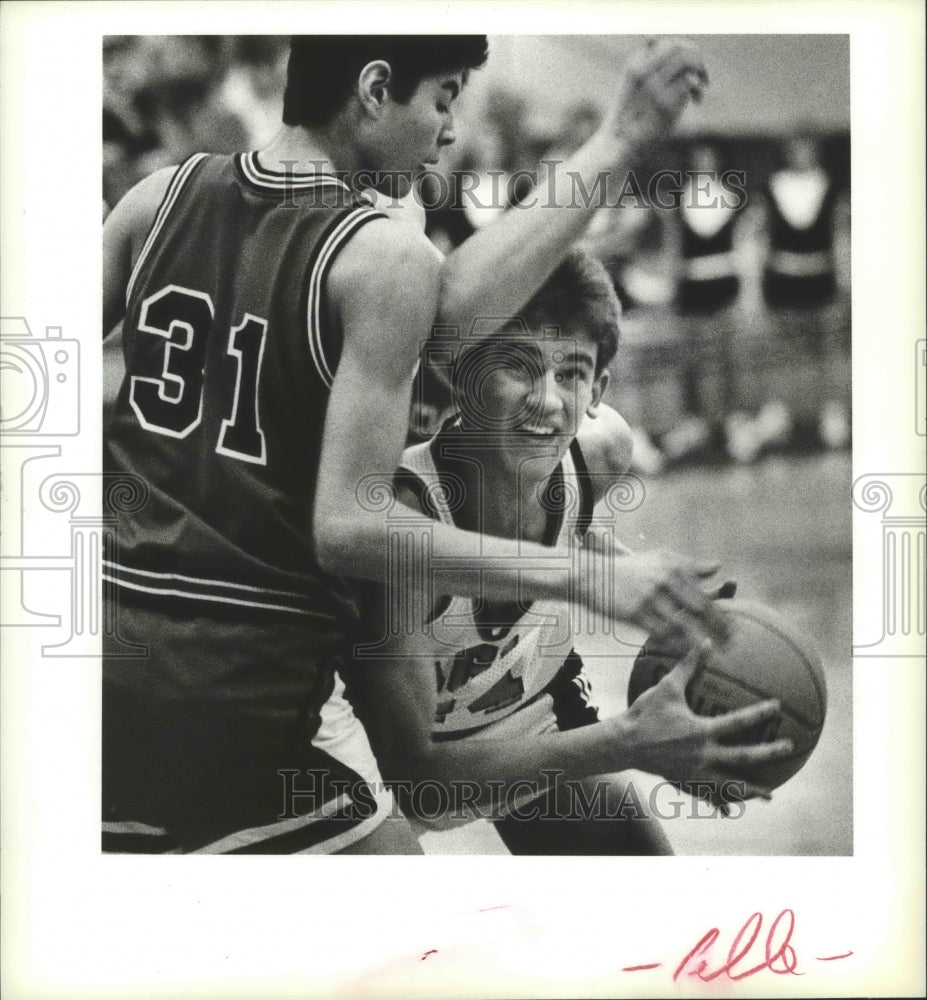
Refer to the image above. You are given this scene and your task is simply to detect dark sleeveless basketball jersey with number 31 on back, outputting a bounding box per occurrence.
[104,153,383,635]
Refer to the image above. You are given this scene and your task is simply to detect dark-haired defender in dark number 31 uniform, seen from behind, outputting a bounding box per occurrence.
[103,36,725,853]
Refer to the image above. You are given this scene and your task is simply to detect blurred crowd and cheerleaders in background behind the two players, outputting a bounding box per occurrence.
[103,35,851,474]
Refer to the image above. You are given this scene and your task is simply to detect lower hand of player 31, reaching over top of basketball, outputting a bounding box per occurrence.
[581,533,729,657]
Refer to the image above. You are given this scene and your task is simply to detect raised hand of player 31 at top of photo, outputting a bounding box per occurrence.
[602,38,708,151]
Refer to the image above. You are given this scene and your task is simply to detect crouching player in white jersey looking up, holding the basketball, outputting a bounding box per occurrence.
[349,251,790,854]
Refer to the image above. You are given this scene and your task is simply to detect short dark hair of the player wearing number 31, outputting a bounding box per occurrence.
[283,35,488,127]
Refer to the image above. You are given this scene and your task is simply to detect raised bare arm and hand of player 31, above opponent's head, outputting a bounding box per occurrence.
[438,39,708,330]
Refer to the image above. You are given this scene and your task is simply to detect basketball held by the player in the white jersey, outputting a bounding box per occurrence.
[628,600,827,789]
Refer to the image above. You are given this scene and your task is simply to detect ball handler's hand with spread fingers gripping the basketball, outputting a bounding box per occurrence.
[624,650,792,804]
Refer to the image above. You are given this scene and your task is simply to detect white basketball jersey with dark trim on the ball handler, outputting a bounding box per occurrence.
[400,434,592,736]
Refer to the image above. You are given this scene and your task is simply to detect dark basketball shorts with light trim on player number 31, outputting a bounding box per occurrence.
[102,602,393,854]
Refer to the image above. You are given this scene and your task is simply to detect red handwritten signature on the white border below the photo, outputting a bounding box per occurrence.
[621,908,853,983]
